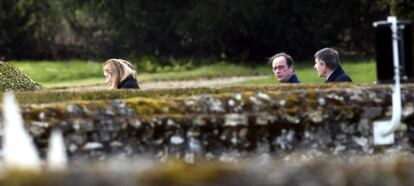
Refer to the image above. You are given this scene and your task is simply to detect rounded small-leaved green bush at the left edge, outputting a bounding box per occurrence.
[0,61,42,92]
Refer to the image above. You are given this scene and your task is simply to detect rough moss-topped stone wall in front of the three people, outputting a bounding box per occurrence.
[11,86,414,161]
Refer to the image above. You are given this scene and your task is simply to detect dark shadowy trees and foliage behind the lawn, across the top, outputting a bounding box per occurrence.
[0,0,414,62]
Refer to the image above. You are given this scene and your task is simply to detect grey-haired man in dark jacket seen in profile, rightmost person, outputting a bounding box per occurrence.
[313,48,352,83]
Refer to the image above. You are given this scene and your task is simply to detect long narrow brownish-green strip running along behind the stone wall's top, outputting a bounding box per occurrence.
[10,84,363,104]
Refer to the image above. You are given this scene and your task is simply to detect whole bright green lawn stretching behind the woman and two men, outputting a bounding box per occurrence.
[11,59,376,87]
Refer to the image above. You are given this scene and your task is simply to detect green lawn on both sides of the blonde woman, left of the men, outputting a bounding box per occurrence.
[12,61,269,87]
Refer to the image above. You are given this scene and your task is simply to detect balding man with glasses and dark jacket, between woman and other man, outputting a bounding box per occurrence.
[269,53,300,83]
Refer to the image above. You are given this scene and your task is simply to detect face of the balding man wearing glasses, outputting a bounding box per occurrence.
[272,56,293,82]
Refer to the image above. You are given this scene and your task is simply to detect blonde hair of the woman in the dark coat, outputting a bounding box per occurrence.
[103,59,137,89]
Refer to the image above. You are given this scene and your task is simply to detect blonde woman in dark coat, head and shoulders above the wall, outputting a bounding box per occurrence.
[103,59,139,89]
